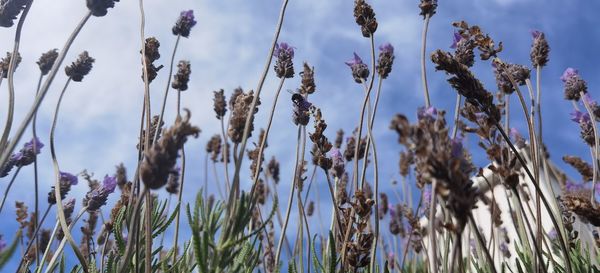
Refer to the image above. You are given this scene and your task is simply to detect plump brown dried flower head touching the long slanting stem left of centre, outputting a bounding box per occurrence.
[227,91,260,143]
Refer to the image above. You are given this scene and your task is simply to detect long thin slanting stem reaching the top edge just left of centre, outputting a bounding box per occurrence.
[227,0,289,210]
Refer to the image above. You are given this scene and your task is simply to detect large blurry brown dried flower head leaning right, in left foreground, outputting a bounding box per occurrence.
[140,109,200,190]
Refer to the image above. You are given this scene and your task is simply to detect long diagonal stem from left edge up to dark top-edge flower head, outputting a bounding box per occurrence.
[0,11,92,169]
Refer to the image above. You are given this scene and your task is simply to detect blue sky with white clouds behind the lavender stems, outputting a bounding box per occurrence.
[0,0,600,269]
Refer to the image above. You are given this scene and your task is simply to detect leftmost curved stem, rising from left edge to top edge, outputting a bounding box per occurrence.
[0,0,33,154]
